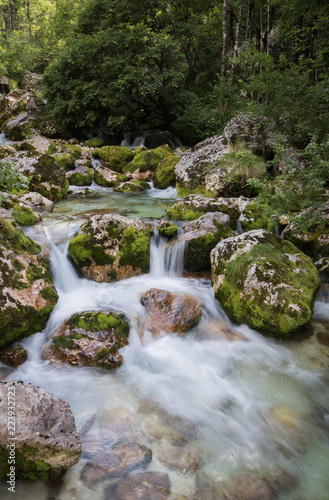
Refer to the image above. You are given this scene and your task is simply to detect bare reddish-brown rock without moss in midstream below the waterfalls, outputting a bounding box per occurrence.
[141,288,202,333]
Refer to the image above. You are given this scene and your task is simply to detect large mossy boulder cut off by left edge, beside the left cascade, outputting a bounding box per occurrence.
[0,219,58,347]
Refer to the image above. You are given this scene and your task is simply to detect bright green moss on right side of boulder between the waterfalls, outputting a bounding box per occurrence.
[118,226,150,272]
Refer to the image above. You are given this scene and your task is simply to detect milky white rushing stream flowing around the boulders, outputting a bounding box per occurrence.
[0,182,329,500]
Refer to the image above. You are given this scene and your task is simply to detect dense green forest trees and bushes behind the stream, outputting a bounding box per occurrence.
[0,0,329,148]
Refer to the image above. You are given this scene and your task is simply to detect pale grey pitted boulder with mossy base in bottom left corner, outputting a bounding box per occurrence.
[0,382,81,480]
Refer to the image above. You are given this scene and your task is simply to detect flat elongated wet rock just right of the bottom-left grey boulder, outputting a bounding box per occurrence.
[81,443,152,484]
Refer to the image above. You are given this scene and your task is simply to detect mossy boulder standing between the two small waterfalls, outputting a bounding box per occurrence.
[69,214,152,282]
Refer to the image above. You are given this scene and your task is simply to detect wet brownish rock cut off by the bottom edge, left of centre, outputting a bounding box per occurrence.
[105,471,171,500]
